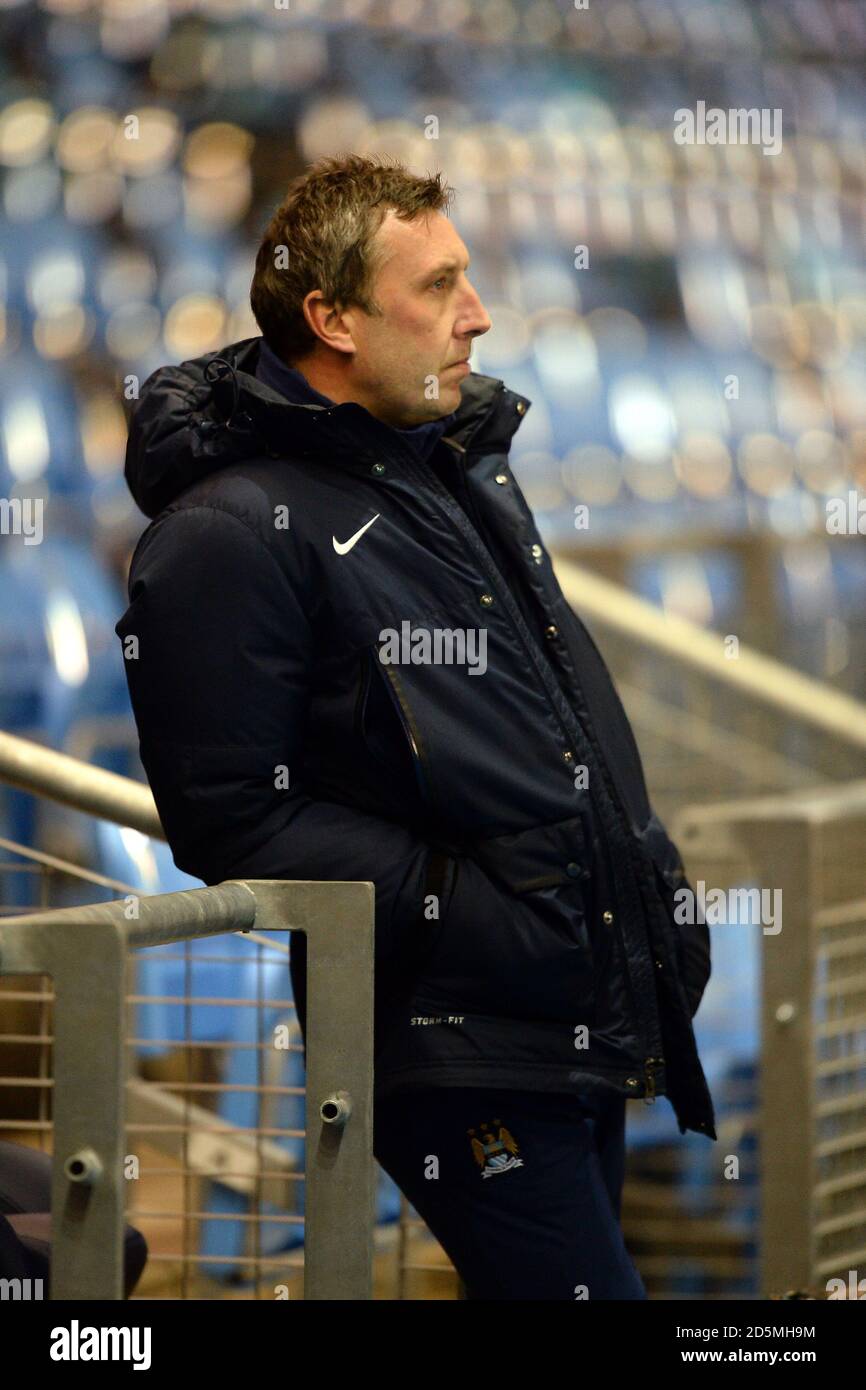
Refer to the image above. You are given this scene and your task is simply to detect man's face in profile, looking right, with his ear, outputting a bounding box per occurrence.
[343,210,491,430]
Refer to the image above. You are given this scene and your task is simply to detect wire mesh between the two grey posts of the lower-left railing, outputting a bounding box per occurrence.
[126,935,304,1298]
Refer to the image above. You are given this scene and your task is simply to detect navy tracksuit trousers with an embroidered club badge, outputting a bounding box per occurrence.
[374,1087,646,1300]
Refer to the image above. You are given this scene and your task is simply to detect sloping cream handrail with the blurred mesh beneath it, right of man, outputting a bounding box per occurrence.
[555,557,866,821]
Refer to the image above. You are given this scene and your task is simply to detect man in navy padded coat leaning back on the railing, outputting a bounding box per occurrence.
[117,156,716,1298]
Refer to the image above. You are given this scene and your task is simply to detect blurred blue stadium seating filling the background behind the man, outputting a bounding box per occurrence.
[0,0,866,1297]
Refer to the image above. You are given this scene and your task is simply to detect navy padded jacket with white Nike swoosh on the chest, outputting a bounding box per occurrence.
[115,338,716,1138]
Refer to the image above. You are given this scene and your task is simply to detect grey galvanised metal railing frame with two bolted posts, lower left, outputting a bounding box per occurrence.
[0,880,375,1298]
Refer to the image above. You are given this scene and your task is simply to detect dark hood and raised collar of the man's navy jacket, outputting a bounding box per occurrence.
[124,338,530,518]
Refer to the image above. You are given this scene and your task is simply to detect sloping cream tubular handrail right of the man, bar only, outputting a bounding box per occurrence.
[553,556,866,748]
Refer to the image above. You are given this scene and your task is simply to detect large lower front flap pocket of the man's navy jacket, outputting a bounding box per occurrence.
[418,820,595,1026]
